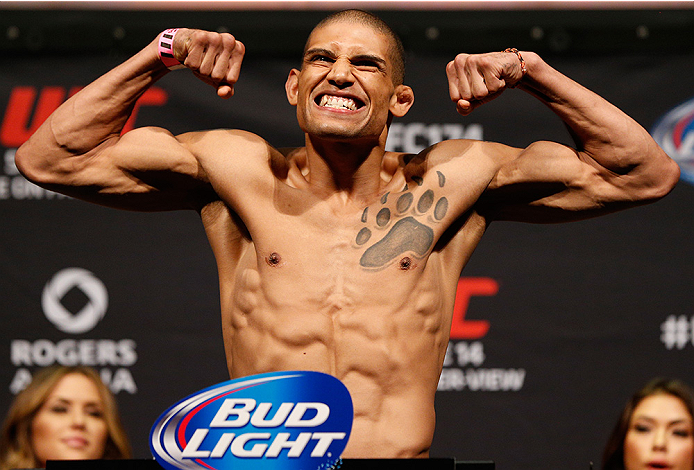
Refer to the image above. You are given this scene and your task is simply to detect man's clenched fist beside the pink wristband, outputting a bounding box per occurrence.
[173,28,246,98]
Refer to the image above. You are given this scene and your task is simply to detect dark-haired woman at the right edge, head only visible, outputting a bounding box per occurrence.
[602,378,694,470]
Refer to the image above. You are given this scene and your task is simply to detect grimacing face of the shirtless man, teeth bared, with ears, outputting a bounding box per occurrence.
[287,21,411,141]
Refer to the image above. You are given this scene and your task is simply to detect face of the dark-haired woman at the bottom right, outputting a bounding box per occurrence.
[624,394,694,470]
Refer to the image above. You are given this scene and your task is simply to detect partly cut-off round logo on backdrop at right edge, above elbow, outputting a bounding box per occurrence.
[651,98,694,184]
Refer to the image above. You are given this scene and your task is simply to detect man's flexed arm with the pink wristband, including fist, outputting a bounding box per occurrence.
[15,29,244,210]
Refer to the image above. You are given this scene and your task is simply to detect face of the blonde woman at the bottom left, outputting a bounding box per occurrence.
[31,373,108,466]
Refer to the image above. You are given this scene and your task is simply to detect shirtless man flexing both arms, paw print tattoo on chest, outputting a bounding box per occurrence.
[16,11,679,458]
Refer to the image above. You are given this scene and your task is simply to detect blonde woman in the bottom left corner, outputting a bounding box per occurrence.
[0,366,130,470]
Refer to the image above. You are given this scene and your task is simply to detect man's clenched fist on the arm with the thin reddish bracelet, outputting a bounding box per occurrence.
[446,52,523,116]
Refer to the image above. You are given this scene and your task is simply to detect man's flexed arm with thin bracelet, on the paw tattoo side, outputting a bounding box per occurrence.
[446,52,679,222]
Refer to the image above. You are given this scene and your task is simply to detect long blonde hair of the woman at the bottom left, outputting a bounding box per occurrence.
[0,365,131,470]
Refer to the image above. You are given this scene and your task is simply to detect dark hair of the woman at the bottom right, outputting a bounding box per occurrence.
[602,377,694,470]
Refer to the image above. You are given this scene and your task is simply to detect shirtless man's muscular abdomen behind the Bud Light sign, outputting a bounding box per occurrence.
[222,247,452,458]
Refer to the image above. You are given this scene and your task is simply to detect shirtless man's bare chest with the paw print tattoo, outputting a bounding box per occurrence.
[249,183,450,274]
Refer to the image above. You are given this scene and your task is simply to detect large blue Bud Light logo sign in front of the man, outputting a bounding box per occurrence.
[150,371,354,470]
